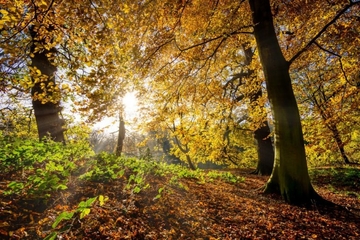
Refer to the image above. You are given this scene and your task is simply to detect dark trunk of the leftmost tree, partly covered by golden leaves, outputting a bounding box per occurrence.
[30,26,65,142]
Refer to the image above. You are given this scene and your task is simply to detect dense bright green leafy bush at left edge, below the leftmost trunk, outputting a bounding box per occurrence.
[0,136,91,199]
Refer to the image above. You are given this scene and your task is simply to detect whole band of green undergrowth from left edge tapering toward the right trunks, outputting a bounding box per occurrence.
[0,135,244,200]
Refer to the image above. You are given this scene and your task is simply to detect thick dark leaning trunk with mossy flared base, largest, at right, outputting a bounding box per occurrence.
[249,0,318,204]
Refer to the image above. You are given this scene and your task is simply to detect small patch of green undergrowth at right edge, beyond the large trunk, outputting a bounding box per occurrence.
[309,167,360,198]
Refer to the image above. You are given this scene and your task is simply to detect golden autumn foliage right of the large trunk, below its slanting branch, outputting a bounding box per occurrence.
[290,1,360,164]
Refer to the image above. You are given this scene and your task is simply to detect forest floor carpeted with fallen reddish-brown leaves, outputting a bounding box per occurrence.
[0,169,360,240]
